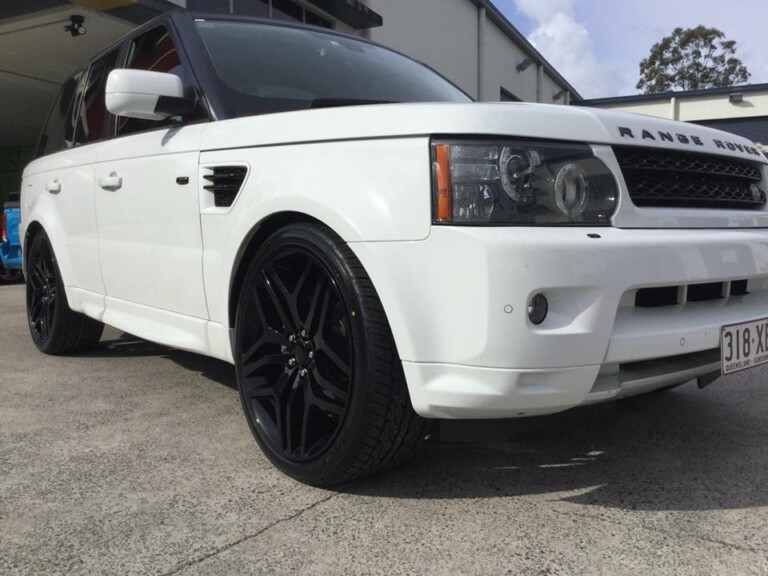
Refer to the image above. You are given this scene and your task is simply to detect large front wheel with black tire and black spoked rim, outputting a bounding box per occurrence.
[235,224,424,486]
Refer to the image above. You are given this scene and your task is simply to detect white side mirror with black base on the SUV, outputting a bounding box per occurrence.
[106,69,195,120]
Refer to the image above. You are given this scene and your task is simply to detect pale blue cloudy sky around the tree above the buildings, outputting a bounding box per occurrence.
[494,0,768,98]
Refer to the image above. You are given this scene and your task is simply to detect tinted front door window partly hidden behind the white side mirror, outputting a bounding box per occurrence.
[117,26,186,136]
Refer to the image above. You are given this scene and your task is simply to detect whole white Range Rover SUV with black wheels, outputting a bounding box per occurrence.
[21,12,768,485]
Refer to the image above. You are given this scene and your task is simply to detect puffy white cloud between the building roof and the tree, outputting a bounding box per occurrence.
[515,0,622,98]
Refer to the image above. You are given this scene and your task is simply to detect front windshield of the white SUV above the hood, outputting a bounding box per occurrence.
[196,20,470,116]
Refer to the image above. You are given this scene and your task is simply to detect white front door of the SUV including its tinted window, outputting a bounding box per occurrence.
[94,25,208,320]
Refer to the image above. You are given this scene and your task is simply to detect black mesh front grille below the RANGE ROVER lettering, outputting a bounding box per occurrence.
[613,146,766,208]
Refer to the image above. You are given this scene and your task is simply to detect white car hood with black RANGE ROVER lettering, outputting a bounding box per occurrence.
[203,103,766,163]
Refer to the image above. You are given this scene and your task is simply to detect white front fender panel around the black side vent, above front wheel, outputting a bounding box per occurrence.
[199,137,431,325]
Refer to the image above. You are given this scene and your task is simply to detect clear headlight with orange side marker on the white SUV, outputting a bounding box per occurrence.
[432,140,619,226]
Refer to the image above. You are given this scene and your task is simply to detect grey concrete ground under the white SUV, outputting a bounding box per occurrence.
[0,286,768,576]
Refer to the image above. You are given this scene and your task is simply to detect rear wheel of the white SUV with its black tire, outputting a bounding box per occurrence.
[26,231,104,355]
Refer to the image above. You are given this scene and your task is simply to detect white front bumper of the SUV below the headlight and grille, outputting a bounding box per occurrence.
[352,226,768,418]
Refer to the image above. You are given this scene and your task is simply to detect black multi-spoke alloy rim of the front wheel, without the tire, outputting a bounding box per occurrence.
[238,246,353,462]
